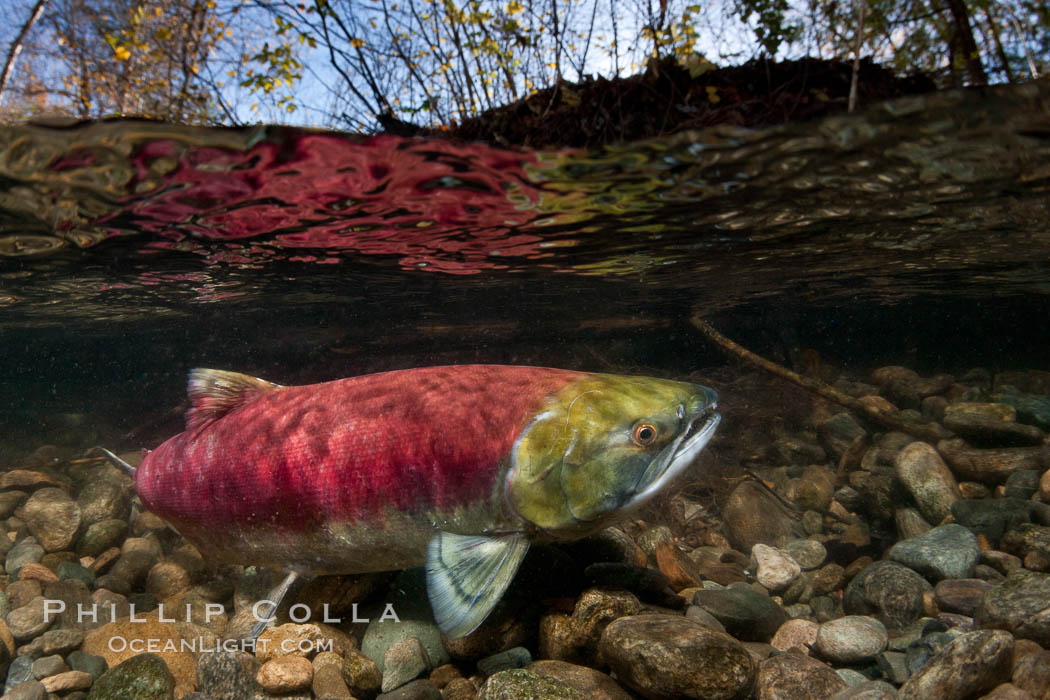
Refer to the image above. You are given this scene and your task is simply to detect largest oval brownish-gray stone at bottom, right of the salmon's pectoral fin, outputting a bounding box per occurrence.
[600,614,756,699]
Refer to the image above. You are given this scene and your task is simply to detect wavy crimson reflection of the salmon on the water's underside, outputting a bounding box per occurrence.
[123,131,546,274]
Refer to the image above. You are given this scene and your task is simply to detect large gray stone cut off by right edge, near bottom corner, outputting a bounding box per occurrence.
[973,570,1050,646]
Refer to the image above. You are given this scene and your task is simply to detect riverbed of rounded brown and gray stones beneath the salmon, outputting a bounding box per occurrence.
[0,366,1050,700]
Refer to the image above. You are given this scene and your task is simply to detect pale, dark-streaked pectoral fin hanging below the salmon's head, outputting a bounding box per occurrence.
[426,531,528,639]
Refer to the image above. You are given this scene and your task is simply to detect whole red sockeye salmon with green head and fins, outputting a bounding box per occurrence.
[134,365,720,638]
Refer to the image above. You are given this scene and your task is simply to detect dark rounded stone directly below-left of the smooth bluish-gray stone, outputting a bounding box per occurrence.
[839,561,933,631]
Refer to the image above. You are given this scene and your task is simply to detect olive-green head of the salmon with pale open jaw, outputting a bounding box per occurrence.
[507,375,720,536]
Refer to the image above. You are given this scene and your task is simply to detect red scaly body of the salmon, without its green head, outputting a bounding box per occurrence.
[135,365,581,570]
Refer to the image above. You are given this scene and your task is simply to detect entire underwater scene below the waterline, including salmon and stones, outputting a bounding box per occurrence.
[0,80,1050,700]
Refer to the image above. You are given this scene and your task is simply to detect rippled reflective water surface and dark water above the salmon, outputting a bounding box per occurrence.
[0,82,1050,451]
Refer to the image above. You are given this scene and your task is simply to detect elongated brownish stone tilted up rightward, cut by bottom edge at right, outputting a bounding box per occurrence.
[899,630,1013,700]
